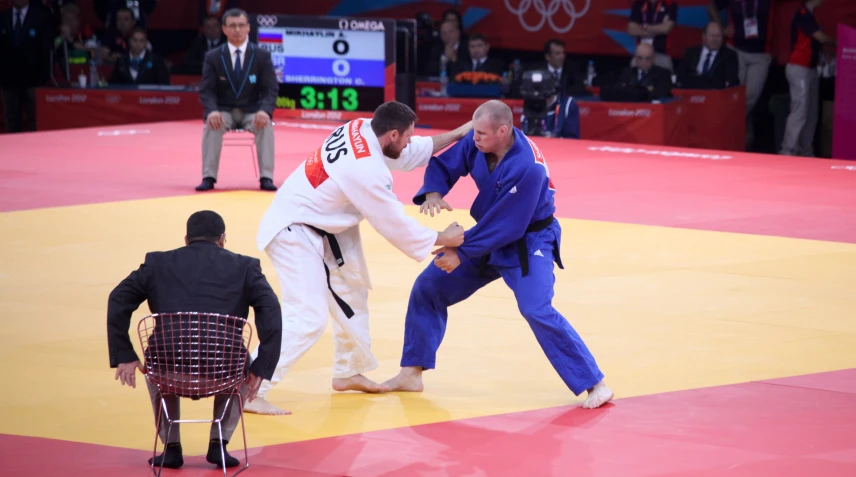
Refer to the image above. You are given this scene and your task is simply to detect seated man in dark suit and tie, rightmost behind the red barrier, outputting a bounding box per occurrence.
[677,22,740,89]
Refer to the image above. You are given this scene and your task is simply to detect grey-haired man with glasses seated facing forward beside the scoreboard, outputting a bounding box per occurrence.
[196,9,279,191]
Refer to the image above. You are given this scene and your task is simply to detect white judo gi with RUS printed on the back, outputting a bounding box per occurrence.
[253,119,438,398]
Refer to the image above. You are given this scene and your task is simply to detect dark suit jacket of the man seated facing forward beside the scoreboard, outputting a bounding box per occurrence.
[199,43,279,118]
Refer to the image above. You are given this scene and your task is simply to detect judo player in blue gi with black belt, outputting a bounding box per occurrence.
[386,100,613,408]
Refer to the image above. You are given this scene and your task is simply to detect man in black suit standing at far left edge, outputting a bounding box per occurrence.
[0,0,55,132]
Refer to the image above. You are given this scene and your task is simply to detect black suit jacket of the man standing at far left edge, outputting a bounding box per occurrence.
[0,2,54,88]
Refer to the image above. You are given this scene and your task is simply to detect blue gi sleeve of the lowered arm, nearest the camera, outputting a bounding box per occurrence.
[458,162,547,259]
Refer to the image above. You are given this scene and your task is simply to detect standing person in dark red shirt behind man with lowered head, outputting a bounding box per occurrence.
[627,0,678,73]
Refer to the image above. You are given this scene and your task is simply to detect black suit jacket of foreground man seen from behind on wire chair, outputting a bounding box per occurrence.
[107,242,282,380]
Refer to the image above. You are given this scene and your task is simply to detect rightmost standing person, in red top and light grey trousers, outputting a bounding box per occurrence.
[779,0,835,157]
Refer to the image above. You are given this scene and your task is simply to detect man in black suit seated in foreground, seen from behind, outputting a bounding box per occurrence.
[107,210,282,469]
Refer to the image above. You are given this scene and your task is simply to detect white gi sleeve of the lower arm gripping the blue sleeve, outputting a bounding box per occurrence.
[336,161,438,261]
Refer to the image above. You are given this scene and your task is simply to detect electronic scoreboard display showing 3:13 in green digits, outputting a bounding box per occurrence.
[250,15,395,112]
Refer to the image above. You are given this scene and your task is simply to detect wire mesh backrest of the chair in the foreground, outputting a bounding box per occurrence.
[137,312,253,399]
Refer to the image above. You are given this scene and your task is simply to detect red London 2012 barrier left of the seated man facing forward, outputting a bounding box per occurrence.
[36,88,203,131]
